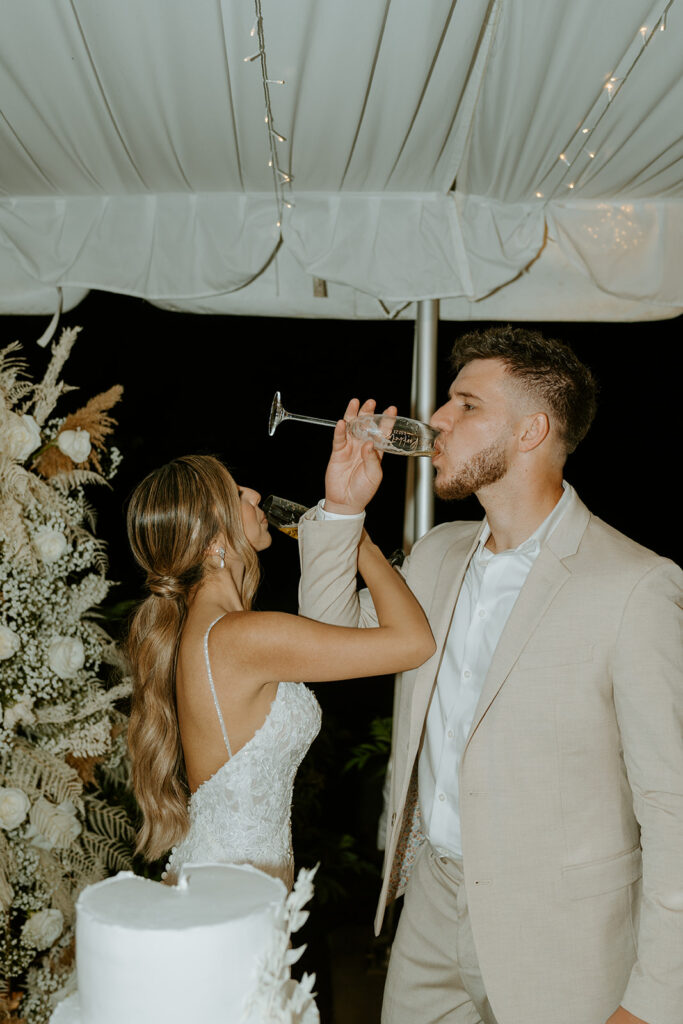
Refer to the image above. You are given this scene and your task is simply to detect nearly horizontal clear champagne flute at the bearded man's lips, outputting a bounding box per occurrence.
[268,391,438,457]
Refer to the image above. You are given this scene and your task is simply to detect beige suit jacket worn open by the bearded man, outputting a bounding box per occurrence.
[299,491,683,1024]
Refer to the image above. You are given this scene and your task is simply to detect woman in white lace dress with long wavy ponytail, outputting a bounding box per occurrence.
[128,436,434,887]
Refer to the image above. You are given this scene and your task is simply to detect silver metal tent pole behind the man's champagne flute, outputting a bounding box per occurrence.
[403,299,438,553]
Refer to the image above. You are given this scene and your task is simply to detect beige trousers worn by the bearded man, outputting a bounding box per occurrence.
[382,843,497,1024]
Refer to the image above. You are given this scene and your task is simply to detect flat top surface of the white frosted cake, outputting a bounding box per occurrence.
[78,864,287,932]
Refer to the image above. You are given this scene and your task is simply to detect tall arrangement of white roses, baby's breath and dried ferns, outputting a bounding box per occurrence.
[0,328,133,1024]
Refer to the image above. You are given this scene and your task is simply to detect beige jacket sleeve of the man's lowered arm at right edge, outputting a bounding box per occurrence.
[613,563,683,1024]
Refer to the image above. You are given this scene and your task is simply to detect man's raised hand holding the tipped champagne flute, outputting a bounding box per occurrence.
[325,398,396,515]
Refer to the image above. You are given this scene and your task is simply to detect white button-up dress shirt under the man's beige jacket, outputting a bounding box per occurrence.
[418,482,577,857]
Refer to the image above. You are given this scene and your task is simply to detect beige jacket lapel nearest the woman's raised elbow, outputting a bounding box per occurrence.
[410,522,483,748]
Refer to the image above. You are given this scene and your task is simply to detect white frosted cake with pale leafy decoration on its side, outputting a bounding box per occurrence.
[50,864,318,1024]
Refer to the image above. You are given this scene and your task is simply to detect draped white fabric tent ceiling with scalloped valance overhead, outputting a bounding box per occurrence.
[0,0,683,321]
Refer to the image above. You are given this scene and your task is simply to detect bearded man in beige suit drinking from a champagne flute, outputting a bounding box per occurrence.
[299,327,683,1024]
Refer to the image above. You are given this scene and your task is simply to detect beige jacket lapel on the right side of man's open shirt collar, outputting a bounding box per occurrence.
[465,491,590,750]
